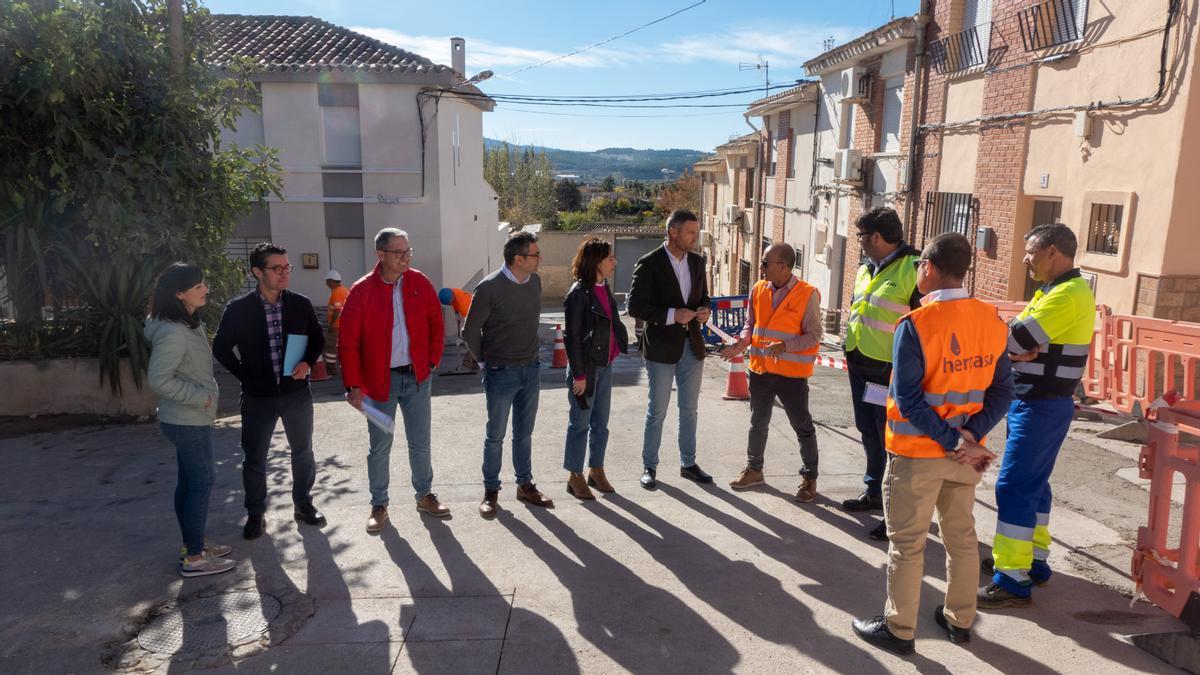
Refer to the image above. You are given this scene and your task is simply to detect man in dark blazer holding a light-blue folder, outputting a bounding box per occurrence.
[212,241,325,539]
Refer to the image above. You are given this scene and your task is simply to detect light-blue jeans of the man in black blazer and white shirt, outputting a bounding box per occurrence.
[642,345,704,468]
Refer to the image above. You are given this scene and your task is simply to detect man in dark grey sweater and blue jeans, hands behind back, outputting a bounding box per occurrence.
[462,232,553,518]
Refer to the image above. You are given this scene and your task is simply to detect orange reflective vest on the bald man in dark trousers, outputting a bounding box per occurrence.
[750,280,821,377]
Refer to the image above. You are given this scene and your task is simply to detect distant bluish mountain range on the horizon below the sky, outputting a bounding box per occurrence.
[484,138,710,183]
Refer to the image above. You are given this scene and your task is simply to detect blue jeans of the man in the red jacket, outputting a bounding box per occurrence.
[362,370,433,506]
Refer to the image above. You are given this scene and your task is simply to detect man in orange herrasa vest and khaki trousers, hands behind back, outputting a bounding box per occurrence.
[853,233,1013,655]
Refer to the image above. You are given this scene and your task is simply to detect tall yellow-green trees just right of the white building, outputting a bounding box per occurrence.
[484,143,557,227]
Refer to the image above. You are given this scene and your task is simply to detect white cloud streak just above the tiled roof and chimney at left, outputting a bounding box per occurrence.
[350,26,631,72]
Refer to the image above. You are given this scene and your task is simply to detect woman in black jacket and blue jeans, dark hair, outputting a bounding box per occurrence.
[563,237,629,500]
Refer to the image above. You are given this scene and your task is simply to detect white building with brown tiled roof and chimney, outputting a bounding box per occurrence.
[204,14,505,305]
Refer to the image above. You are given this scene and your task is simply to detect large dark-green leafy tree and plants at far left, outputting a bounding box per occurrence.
[0,0,280,382]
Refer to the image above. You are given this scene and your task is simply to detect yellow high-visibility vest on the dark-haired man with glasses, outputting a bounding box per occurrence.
[846,255,917,363]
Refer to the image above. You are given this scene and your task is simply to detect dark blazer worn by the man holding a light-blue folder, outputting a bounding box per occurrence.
[212,288,325,396]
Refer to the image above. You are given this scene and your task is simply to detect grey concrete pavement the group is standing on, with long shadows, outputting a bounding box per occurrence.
[0,315,1181,674]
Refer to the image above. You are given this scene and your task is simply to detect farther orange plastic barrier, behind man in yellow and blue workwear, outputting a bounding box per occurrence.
[1104,315,1200,416]
